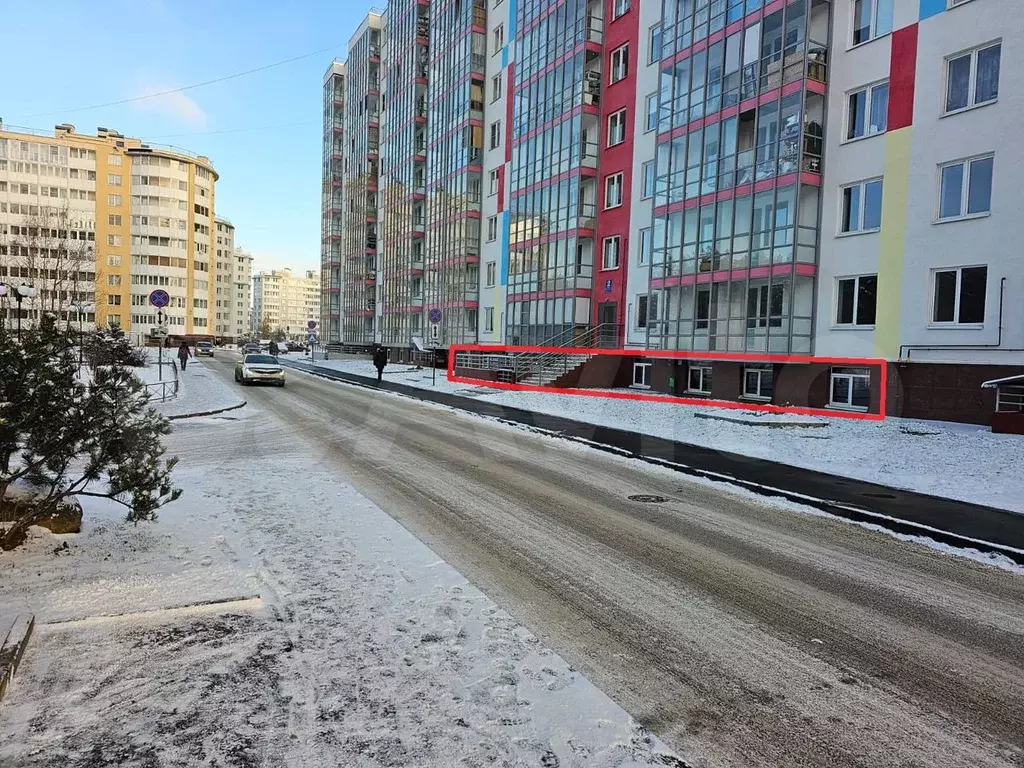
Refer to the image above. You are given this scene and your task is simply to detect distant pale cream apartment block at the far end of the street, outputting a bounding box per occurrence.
[253,269,321,341]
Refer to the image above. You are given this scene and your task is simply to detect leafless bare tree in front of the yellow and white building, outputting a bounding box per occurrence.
[0,200,98,329]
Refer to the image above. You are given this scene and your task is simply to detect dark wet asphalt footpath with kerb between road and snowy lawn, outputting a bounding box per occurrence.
[278,362,1024,565]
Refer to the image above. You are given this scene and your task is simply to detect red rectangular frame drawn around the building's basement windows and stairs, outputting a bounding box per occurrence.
[447,344,889,421]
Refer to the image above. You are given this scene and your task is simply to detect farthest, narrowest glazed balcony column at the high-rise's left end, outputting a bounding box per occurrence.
[321,61,346,344]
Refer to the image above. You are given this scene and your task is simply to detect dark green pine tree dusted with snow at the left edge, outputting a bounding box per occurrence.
[0,315,181,549]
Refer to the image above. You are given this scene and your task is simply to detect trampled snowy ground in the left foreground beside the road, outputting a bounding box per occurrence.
[0,405,682,768]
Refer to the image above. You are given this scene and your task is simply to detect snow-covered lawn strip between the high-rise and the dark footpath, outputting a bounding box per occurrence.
[294,358,1024,513]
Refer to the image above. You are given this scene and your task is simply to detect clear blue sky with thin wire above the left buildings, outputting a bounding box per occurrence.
[0,0,383,269]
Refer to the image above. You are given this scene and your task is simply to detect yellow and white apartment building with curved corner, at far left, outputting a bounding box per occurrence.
[0,124,217,339]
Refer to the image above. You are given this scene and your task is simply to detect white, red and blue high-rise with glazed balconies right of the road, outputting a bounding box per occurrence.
[327,0,1024,421]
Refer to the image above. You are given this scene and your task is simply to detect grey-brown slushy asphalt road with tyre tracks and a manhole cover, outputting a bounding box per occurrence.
[209,358,1024,768]
